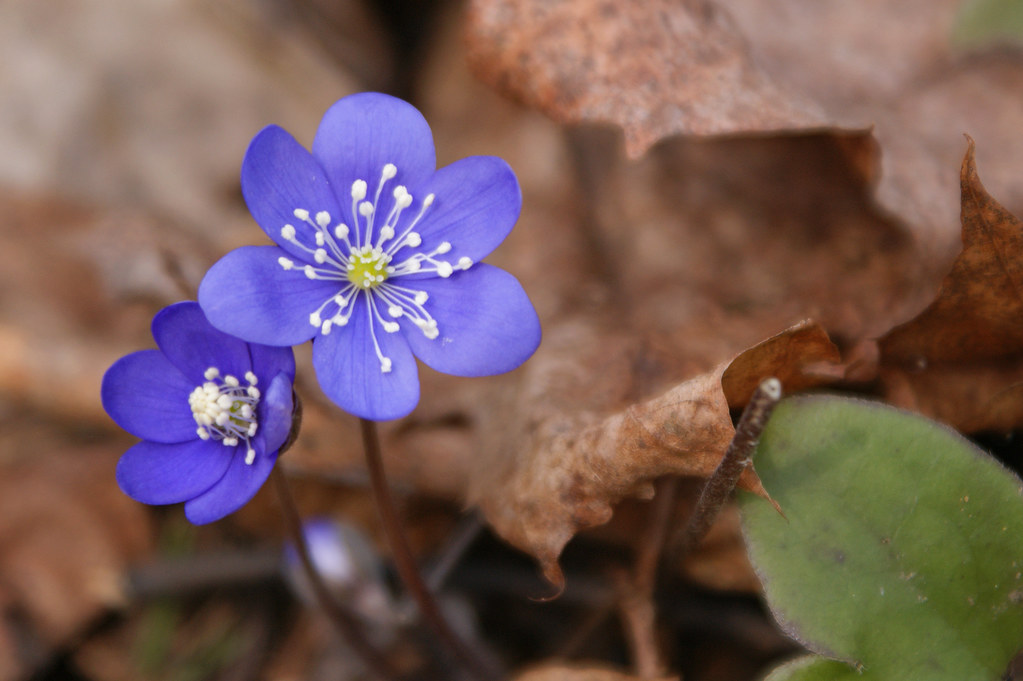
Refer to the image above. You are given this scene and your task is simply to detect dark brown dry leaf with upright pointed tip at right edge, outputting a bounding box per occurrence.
[878,139,1023,429]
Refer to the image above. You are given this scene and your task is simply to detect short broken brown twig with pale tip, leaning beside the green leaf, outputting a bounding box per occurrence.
[672,377,782,556]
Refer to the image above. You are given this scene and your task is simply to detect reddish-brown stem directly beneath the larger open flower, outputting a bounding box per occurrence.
[359,418,501,681]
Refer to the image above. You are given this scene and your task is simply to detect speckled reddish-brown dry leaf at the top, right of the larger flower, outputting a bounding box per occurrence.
[469,0,825,156]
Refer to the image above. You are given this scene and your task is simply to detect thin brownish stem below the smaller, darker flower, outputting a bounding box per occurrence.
[270,465,399,681]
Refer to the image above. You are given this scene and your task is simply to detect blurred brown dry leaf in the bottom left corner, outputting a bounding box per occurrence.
[0,437,149,679]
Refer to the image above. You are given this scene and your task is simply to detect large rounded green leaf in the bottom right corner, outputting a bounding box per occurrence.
[741,397,1023,681]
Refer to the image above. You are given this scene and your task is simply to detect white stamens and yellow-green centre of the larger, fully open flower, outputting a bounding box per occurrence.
[277,164,473,373]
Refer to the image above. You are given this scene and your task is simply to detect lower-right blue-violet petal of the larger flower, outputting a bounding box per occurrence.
[403,264,540,376]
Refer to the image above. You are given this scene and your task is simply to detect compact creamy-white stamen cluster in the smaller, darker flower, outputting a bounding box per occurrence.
[188,366,260,465]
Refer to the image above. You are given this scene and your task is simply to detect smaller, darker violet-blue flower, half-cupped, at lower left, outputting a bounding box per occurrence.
[101,303,295,525]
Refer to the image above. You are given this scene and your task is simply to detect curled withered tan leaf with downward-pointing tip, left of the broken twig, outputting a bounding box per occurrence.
[470,324,836,588]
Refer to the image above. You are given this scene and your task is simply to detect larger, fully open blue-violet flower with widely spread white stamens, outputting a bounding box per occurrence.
[198,93,540,420]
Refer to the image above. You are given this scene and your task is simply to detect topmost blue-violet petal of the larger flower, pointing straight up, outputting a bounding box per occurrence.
[313,92,437,205]
